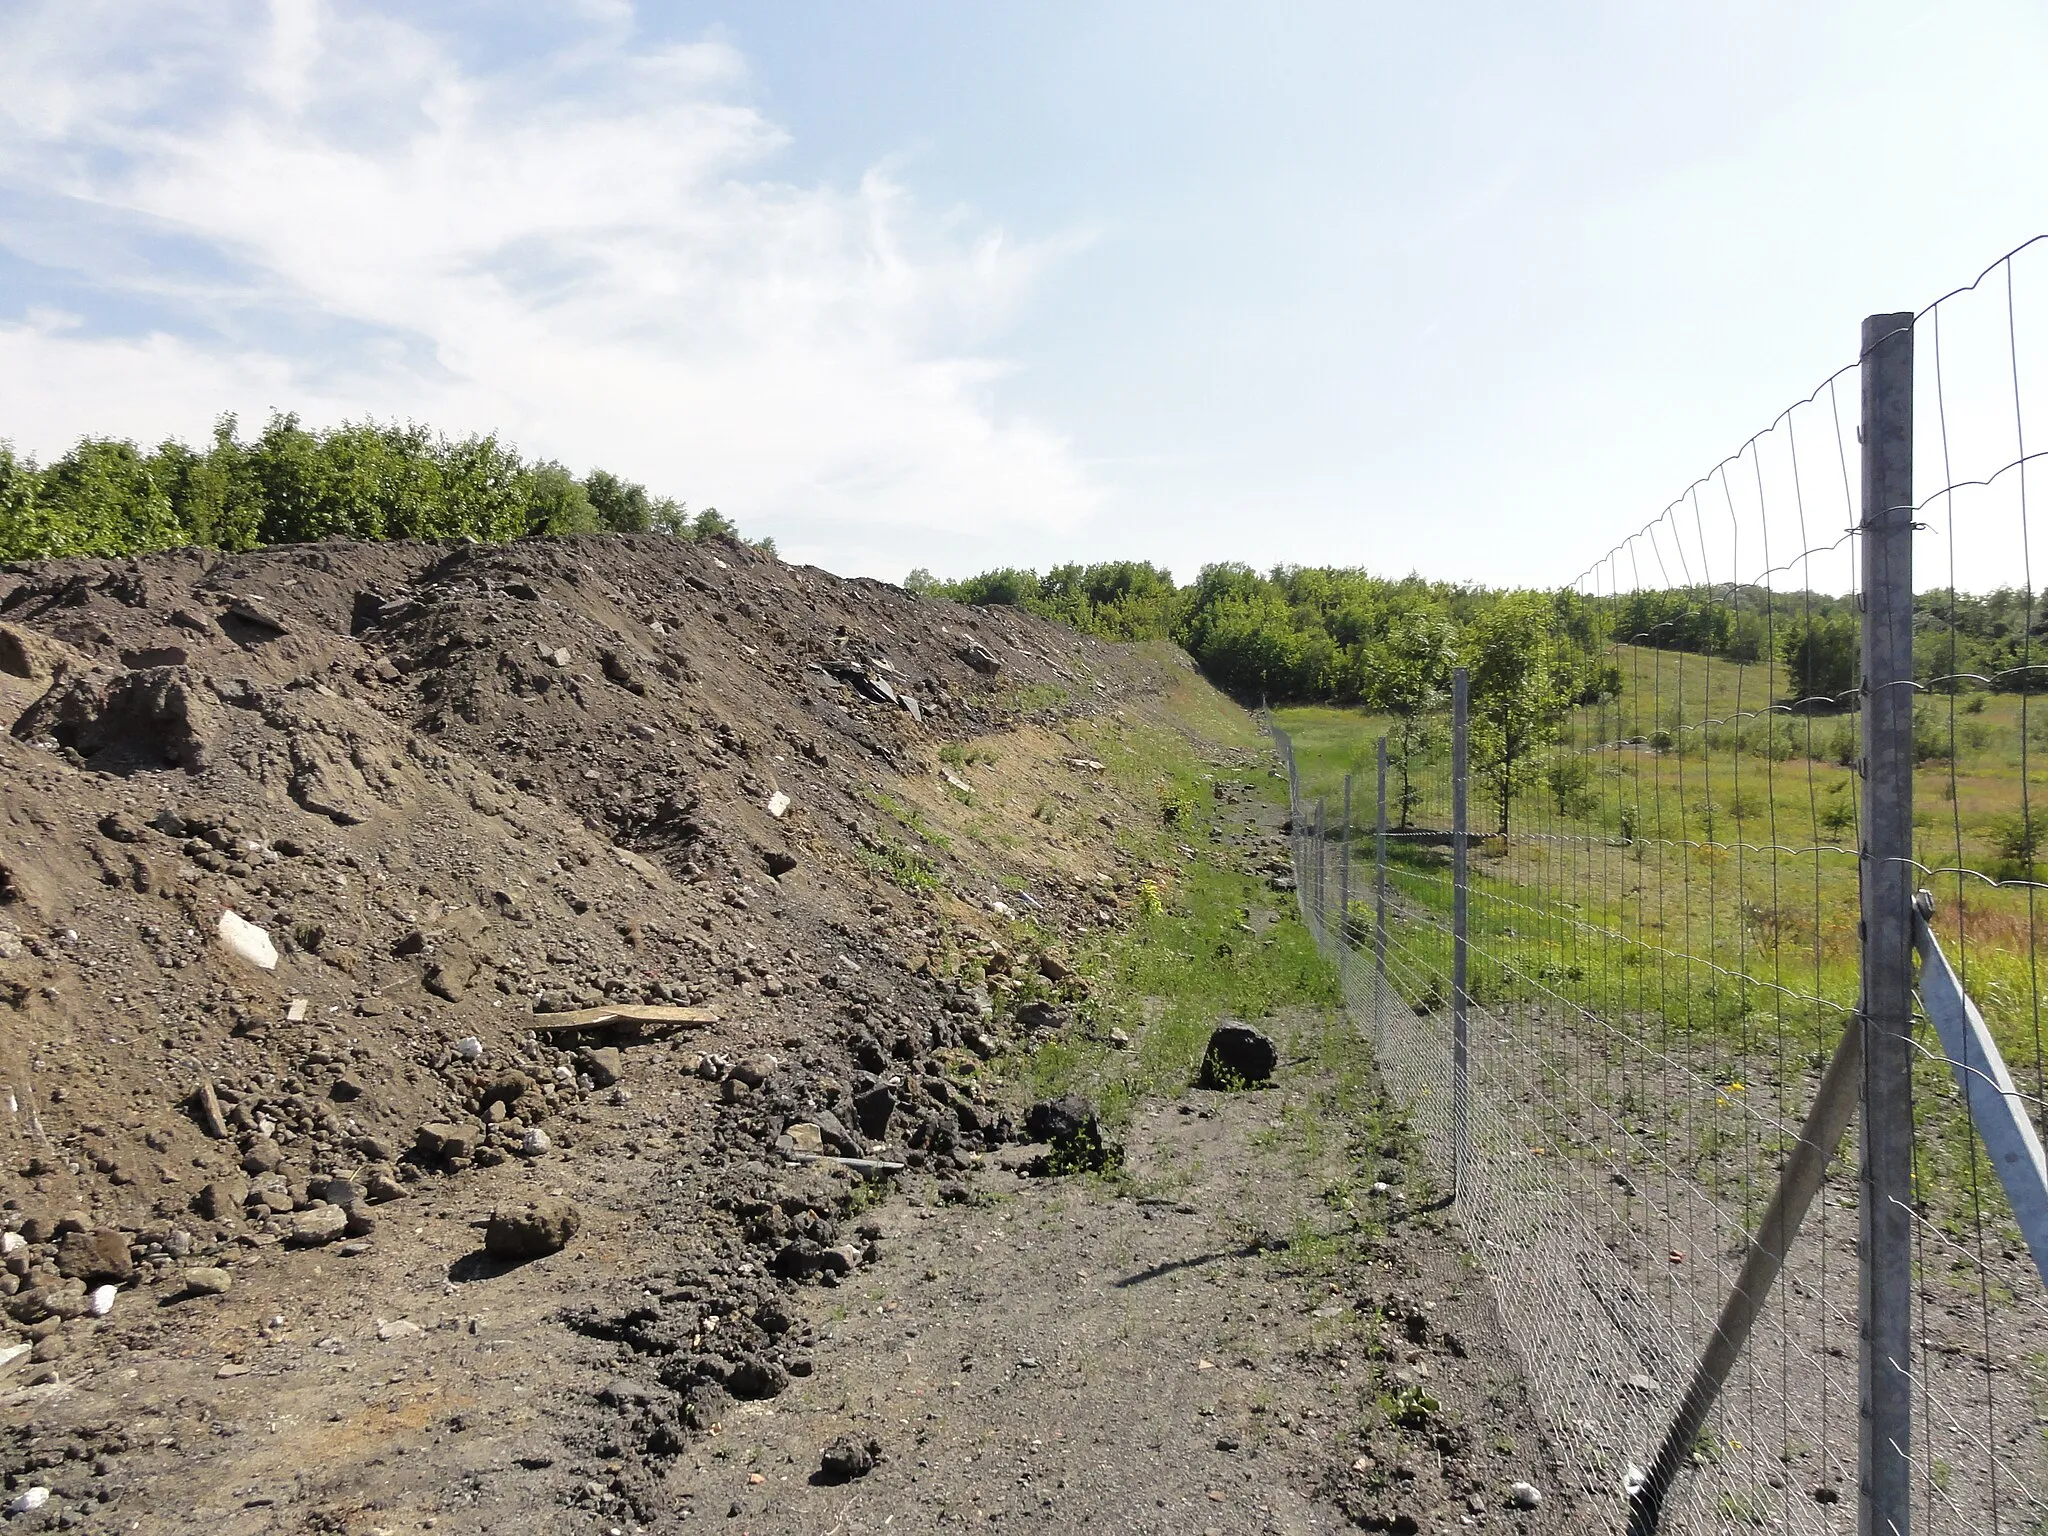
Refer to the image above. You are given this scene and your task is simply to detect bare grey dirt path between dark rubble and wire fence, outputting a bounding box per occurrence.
[672,1018,1559,1536]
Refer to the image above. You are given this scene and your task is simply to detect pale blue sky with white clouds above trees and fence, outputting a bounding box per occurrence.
[0,0,2048,582]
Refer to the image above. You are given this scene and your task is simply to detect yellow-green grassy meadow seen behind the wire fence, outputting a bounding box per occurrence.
[1276,647,2048,1233]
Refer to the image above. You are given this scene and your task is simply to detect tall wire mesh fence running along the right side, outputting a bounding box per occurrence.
[1276,242,2048,1532]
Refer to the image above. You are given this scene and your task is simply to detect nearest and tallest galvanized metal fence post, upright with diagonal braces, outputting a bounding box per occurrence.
[1858,313,1915,1536]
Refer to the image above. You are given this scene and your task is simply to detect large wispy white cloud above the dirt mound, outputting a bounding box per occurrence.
[0,0,1096,575]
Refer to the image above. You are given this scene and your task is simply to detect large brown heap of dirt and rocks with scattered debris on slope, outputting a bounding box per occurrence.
[0,537,1178,1499]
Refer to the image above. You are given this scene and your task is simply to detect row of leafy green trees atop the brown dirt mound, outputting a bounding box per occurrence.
[0,414,772,561]
